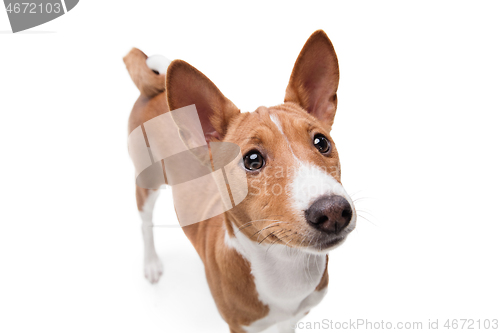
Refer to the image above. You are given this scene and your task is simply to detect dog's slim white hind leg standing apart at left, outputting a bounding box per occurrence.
[137,187,163,283]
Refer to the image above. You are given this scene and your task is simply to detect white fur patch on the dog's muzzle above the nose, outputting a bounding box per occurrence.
[291,163,354,211]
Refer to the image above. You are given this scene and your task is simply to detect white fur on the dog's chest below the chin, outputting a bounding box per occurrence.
[226,226,326,332]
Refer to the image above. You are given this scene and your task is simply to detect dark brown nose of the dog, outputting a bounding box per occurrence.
[306,195,352,235]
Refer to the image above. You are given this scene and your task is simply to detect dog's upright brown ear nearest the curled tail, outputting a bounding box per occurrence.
[167,60,240,142]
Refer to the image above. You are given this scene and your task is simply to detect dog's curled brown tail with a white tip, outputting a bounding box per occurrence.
[123,48,170,98]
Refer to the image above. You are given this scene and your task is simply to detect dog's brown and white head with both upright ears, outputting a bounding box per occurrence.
[167,30,356,253]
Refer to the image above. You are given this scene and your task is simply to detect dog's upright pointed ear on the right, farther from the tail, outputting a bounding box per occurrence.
[285,30,339,128]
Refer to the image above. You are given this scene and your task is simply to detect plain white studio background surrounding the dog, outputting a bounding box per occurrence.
[0,0,500,333]
